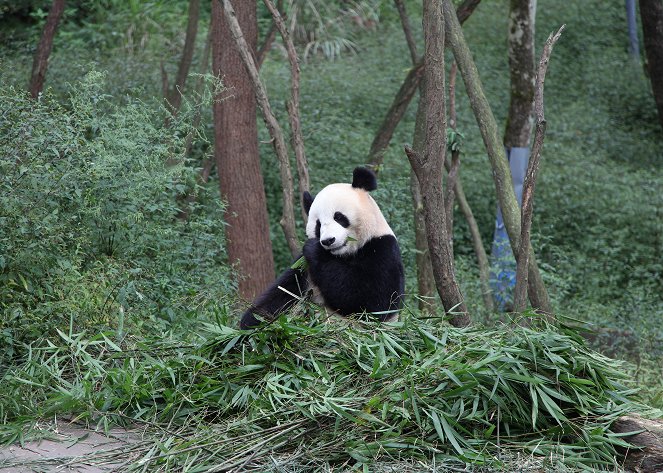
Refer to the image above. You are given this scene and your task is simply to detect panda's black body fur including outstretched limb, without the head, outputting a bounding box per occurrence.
[240,235,405,329]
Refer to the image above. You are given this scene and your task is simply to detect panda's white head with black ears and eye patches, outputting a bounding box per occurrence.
[303,167,394,256]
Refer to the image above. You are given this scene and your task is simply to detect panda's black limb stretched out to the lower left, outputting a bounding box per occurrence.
[239,260,308,330]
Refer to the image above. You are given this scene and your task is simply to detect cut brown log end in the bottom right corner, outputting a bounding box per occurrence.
[610,415,663,473]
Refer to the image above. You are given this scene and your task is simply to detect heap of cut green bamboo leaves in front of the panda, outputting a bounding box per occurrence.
[0,310,652,471]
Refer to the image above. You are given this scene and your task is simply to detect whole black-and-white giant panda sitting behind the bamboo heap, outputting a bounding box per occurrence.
[240,167,404,329]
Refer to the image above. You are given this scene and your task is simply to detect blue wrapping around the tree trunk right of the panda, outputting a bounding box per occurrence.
[490,148,529,311]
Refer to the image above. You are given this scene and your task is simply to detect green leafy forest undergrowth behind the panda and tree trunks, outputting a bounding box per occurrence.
[0,0,663,470]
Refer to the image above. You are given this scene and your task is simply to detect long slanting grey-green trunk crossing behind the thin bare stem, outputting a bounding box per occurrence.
[442,0,552,314]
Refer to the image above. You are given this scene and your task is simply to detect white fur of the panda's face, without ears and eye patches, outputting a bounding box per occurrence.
[306,184,394,255]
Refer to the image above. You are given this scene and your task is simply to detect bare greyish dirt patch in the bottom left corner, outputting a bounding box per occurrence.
[0,421,142,473]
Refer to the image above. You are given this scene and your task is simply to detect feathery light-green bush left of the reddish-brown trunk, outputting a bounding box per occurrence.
[0,73,232,365]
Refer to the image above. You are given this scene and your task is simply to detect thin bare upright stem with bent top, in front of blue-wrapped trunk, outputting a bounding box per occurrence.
[513,25,565,312]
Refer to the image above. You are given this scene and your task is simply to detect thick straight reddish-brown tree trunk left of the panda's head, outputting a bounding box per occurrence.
[212,0,274,300]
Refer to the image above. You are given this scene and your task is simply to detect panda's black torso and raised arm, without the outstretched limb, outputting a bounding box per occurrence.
[304,235,404,319]
